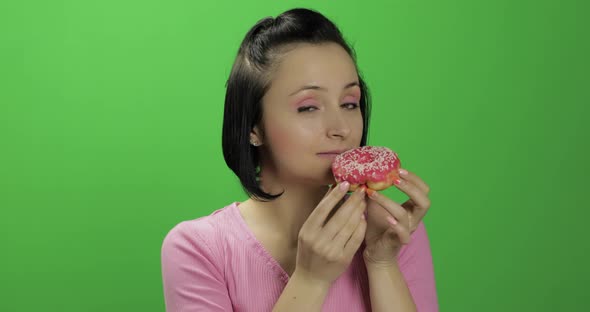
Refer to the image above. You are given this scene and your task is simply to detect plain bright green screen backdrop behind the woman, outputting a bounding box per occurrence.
[0,0,590,311]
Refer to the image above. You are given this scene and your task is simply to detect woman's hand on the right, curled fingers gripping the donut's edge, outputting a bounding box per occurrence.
[363,169,430,263]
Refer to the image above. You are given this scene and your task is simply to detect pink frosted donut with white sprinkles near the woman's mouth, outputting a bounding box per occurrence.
[332,146,401,191]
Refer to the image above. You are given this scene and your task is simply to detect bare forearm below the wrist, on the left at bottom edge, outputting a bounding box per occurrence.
[272,271,330,312]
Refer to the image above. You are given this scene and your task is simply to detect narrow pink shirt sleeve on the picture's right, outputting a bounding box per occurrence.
[398,221,438,312]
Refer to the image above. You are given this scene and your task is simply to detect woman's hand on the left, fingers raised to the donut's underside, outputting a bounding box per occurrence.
[293,182,367,286]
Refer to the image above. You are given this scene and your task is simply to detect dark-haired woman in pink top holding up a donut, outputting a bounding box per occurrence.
[162,9,438,312]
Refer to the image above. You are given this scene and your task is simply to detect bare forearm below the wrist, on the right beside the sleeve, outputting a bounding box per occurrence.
[366,261,417,312]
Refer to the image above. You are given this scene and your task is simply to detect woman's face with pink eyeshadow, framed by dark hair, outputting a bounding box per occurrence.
[257,43,363,185]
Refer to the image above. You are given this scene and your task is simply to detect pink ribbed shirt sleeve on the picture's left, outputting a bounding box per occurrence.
[161,221,232,312]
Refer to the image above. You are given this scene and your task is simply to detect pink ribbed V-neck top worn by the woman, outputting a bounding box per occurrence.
[161,202,438,312]
